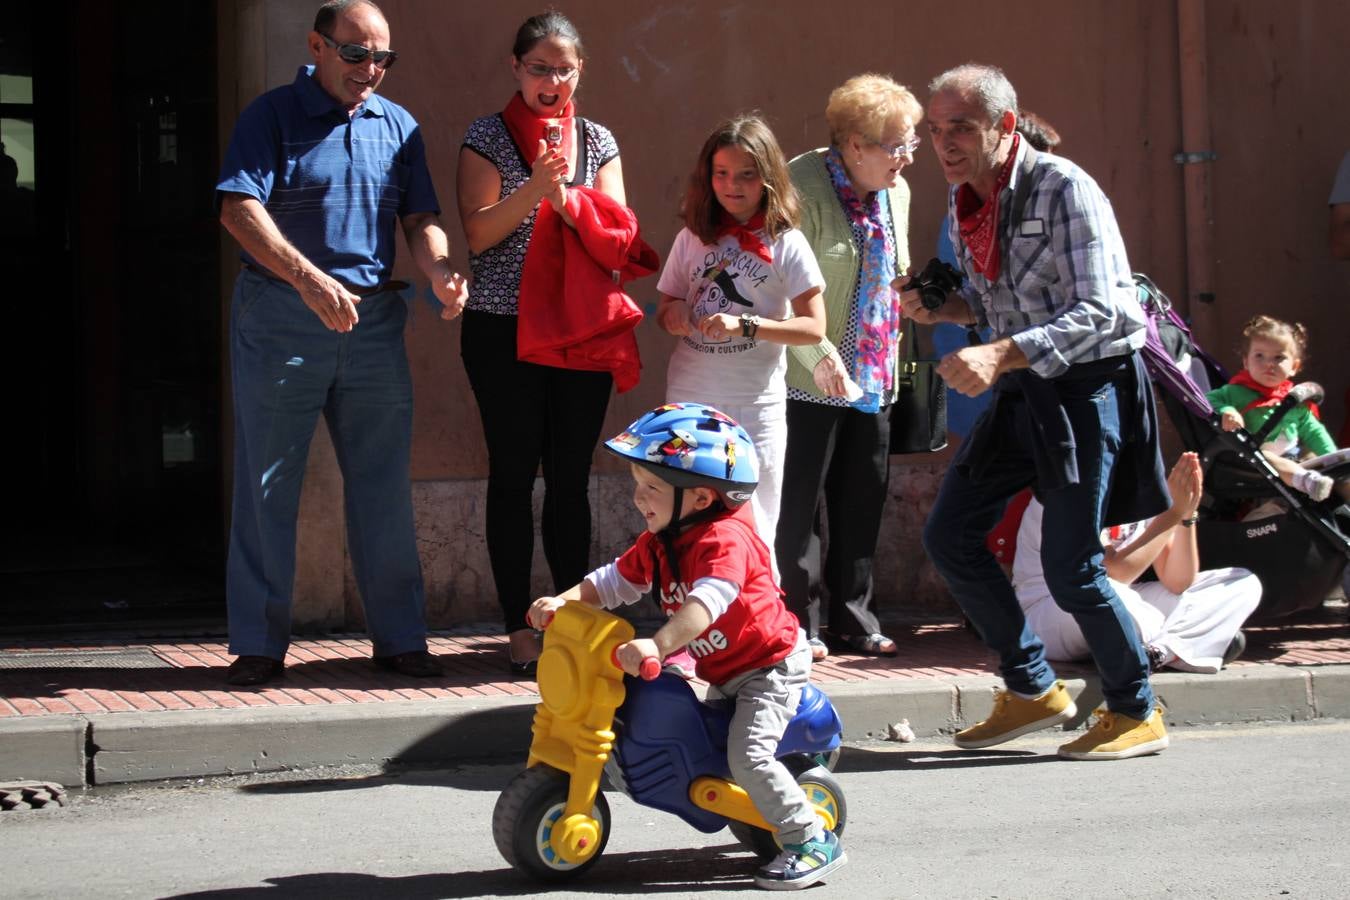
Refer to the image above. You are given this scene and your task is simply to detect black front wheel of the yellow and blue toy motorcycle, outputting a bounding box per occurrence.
[493,765,609,882]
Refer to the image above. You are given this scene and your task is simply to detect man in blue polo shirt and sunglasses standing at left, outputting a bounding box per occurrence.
[216,0,467,684]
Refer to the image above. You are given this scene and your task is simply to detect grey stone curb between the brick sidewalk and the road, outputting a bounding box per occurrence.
[0,665,1350,787]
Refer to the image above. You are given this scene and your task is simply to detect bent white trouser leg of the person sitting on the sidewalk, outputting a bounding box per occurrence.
[1135,568,1261,673]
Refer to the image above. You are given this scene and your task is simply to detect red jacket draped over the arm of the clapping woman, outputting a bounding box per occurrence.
[516,188,660,393]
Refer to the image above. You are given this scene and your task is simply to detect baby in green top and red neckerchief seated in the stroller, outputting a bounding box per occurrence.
[1206,316,1350,502]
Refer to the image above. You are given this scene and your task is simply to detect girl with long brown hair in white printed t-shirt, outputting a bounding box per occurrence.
[656,115,825,553]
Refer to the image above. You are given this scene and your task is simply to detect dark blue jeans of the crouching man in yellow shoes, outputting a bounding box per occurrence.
[923,361,1154,719]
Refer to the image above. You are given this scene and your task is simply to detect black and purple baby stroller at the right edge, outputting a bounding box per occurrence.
[1134,274,1350,618]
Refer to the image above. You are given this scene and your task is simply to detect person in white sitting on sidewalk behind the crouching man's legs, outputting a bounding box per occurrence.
[1013,453,1261,673]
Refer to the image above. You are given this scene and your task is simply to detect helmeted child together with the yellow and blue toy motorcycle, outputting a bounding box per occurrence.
[493,403,845,889]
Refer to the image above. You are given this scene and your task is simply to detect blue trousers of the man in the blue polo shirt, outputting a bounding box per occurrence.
[225,270,427,660]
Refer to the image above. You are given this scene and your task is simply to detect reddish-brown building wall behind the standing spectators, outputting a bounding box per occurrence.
[221,0,1350,625]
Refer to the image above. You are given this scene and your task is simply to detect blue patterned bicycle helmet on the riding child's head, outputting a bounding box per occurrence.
[605,403,759,509]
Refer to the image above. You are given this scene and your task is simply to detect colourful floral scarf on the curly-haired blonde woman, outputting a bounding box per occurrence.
[825,147,900,413]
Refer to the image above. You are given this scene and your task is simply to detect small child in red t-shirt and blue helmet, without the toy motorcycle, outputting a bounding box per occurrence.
[529,403,845,889]
